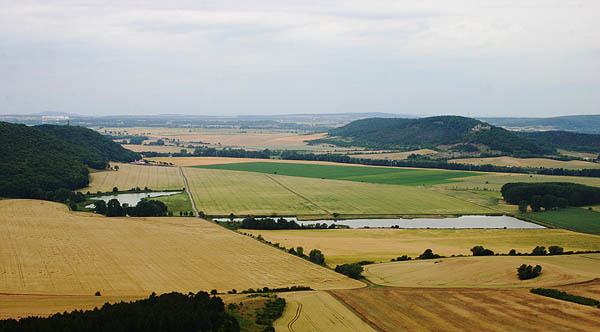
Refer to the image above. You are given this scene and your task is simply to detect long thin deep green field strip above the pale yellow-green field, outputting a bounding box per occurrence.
[198,162,481,186]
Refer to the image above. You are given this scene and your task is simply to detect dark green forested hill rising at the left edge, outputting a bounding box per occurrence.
[0,122,139,198]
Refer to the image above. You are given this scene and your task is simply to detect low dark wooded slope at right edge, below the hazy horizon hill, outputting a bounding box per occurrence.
[518,130,600,152]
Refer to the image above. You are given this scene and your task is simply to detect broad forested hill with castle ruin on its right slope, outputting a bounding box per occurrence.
[313,116,554,155]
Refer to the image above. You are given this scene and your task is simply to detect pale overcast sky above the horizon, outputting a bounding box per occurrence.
[0,0,600,116]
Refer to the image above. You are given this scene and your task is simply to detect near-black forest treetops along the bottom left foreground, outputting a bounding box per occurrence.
[0,292,239,332]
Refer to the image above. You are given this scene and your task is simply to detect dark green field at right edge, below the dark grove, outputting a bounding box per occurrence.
[525,207,600,235]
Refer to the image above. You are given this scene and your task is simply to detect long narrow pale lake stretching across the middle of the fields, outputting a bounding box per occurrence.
[213,216,546,229]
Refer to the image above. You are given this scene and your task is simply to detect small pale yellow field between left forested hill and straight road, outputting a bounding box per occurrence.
[80,163,184,193]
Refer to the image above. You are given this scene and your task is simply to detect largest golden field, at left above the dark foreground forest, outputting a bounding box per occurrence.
[0,200,363,316]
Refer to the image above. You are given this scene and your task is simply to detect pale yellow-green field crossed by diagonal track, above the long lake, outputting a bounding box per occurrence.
[184,165,496,216]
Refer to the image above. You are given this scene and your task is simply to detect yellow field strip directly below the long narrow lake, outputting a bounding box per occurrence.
[240,228,600,266]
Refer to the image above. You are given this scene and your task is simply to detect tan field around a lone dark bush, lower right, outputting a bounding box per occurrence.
[363,254,600,288]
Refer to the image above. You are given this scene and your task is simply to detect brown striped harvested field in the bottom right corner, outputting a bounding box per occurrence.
[332,287,600,332]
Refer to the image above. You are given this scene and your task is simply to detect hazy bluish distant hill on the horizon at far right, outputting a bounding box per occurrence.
[481,114,600,134]
